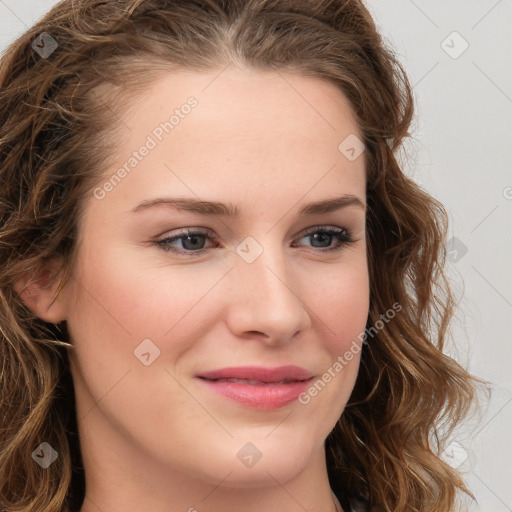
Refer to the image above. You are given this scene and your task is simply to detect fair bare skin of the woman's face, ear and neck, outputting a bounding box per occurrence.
[20,65,369,512]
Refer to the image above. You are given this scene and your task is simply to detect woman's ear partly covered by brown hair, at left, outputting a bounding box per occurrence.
[14,259,66,324]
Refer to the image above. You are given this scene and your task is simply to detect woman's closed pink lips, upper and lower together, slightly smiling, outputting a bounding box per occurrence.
[198,366,313,410]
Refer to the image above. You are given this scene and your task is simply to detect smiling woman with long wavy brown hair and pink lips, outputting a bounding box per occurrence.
[0,0,484,512]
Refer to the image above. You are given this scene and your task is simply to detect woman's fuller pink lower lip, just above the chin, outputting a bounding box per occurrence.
[200,379,311,410]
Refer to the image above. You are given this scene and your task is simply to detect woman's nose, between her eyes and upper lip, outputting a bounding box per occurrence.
[227,248,311,345]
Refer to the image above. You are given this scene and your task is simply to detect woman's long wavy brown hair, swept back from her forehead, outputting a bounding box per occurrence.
[0,0,488,512]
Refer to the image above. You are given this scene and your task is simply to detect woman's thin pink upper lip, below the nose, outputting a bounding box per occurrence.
[198,365,313,383]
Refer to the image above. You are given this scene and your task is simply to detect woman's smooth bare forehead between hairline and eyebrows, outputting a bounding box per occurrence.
[90,67,365,214]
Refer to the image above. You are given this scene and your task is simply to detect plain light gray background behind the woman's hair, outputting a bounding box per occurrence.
[0,0,512,512]
